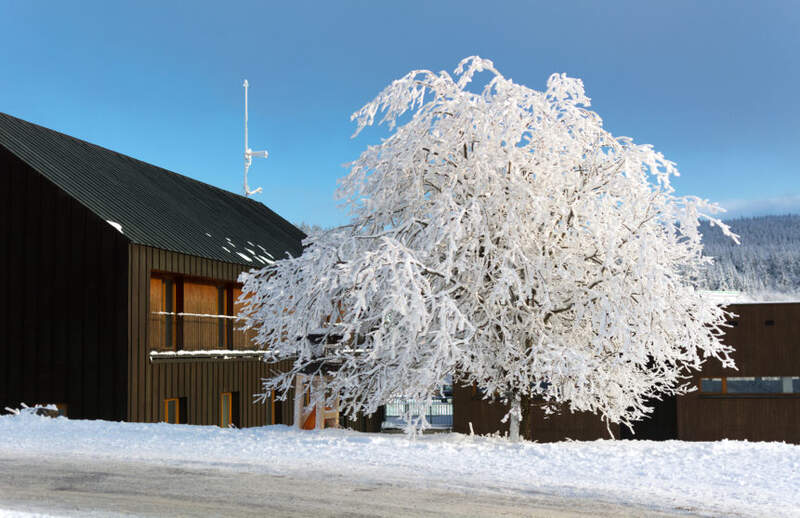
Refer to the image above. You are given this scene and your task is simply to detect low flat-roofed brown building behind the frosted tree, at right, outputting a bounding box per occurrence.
[453,302,800,444]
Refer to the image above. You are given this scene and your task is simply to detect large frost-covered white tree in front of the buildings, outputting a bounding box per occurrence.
[244,57,733,438]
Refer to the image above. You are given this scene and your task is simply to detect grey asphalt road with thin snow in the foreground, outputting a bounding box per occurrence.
[0,455,691,518]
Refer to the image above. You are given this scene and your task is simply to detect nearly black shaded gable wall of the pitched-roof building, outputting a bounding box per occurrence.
[0,148,128,420]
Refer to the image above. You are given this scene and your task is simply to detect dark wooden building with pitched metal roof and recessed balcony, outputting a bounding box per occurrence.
[0,114,304,426]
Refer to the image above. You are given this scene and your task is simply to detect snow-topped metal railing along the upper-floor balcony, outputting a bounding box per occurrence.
[148,311,257,351]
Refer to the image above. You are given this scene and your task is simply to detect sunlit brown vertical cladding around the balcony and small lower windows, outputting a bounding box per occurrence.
[128,245,292,427]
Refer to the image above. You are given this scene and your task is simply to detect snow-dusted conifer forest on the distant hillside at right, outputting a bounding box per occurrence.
[700,215,800,297]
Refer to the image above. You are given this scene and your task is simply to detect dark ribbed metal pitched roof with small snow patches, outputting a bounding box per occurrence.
[0,113,305,267]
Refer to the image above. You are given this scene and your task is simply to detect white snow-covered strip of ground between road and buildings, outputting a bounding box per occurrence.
[0,414,800,516]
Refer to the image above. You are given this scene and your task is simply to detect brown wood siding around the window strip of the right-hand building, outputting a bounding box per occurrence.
[678,303,800,443]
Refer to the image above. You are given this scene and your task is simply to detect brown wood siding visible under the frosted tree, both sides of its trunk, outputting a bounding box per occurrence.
[453,383,620,442]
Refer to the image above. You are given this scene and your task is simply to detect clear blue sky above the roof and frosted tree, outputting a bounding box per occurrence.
[0,0,800,225]
